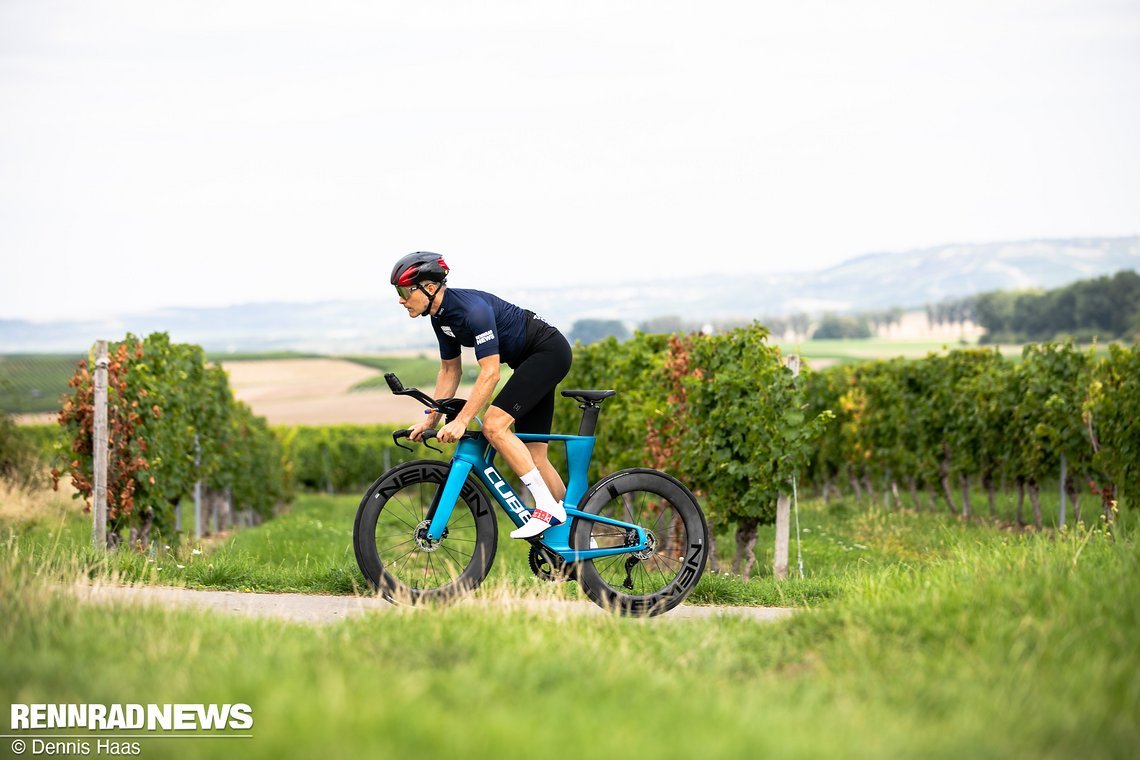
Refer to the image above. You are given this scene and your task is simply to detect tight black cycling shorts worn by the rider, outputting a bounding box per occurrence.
[491,311,572,434]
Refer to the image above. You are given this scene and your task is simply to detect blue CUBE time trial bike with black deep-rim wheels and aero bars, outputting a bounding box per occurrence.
[352,373,709,616]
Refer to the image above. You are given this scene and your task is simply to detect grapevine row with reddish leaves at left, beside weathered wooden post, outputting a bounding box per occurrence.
[51,333,288,547]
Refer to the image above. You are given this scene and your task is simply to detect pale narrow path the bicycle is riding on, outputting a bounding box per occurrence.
[71,585,793,624]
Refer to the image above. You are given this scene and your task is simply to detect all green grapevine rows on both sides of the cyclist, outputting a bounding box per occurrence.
[6,325,1140,572]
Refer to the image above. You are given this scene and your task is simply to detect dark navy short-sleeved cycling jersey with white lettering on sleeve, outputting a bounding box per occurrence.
[431,287,527,367]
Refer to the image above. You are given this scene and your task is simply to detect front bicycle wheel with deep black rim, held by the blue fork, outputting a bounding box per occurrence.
[352,459,498,605]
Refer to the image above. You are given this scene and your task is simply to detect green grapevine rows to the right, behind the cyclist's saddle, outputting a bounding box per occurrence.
[555,326,1140,556]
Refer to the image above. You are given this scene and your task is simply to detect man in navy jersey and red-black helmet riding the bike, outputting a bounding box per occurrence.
[391,251,571,539]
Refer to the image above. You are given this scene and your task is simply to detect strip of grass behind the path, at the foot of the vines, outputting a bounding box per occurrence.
[0,480,1121,607]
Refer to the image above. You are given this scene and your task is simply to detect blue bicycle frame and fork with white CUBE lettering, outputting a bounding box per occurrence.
[428,433,649,562]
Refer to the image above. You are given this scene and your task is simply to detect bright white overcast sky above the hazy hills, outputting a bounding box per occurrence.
[0,0,1140,319]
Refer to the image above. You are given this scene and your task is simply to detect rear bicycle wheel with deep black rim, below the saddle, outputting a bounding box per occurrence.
[571,468,709,616]
